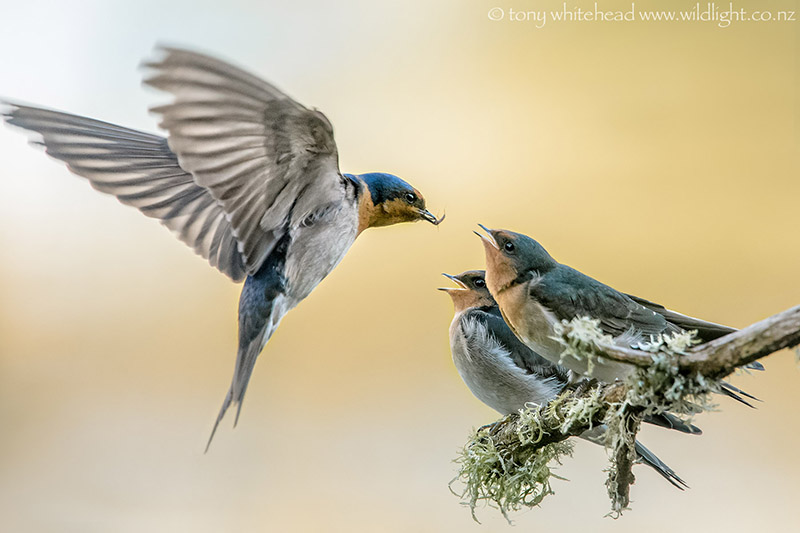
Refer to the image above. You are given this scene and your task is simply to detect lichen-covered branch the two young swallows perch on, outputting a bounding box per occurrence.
[451,306,800,518]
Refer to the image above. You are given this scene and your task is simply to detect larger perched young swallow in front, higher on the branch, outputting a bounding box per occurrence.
[476,225,763,405]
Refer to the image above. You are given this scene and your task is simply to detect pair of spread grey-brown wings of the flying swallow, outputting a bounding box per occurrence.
[3,49,343,281]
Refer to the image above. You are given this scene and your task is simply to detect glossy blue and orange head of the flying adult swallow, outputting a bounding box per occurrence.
[347,172,444,230]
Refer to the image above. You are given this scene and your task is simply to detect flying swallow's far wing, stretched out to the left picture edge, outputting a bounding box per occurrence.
[3,103,245,281]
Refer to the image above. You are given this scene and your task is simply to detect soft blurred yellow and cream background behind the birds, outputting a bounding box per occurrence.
[0,0,800,533]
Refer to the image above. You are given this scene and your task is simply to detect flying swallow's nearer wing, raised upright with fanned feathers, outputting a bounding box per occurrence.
[145,48,343,275]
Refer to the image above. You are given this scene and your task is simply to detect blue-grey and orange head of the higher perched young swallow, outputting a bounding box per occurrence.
[475,224,558,295]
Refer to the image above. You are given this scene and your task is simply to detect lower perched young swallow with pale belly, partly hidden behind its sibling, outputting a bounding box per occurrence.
[439,270,701,488]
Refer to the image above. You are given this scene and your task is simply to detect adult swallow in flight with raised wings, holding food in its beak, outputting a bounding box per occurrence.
[3,48,444,450]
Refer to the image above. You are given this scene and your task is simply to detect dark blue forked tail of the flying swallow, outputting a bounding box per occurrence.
[205,245,292,452]
